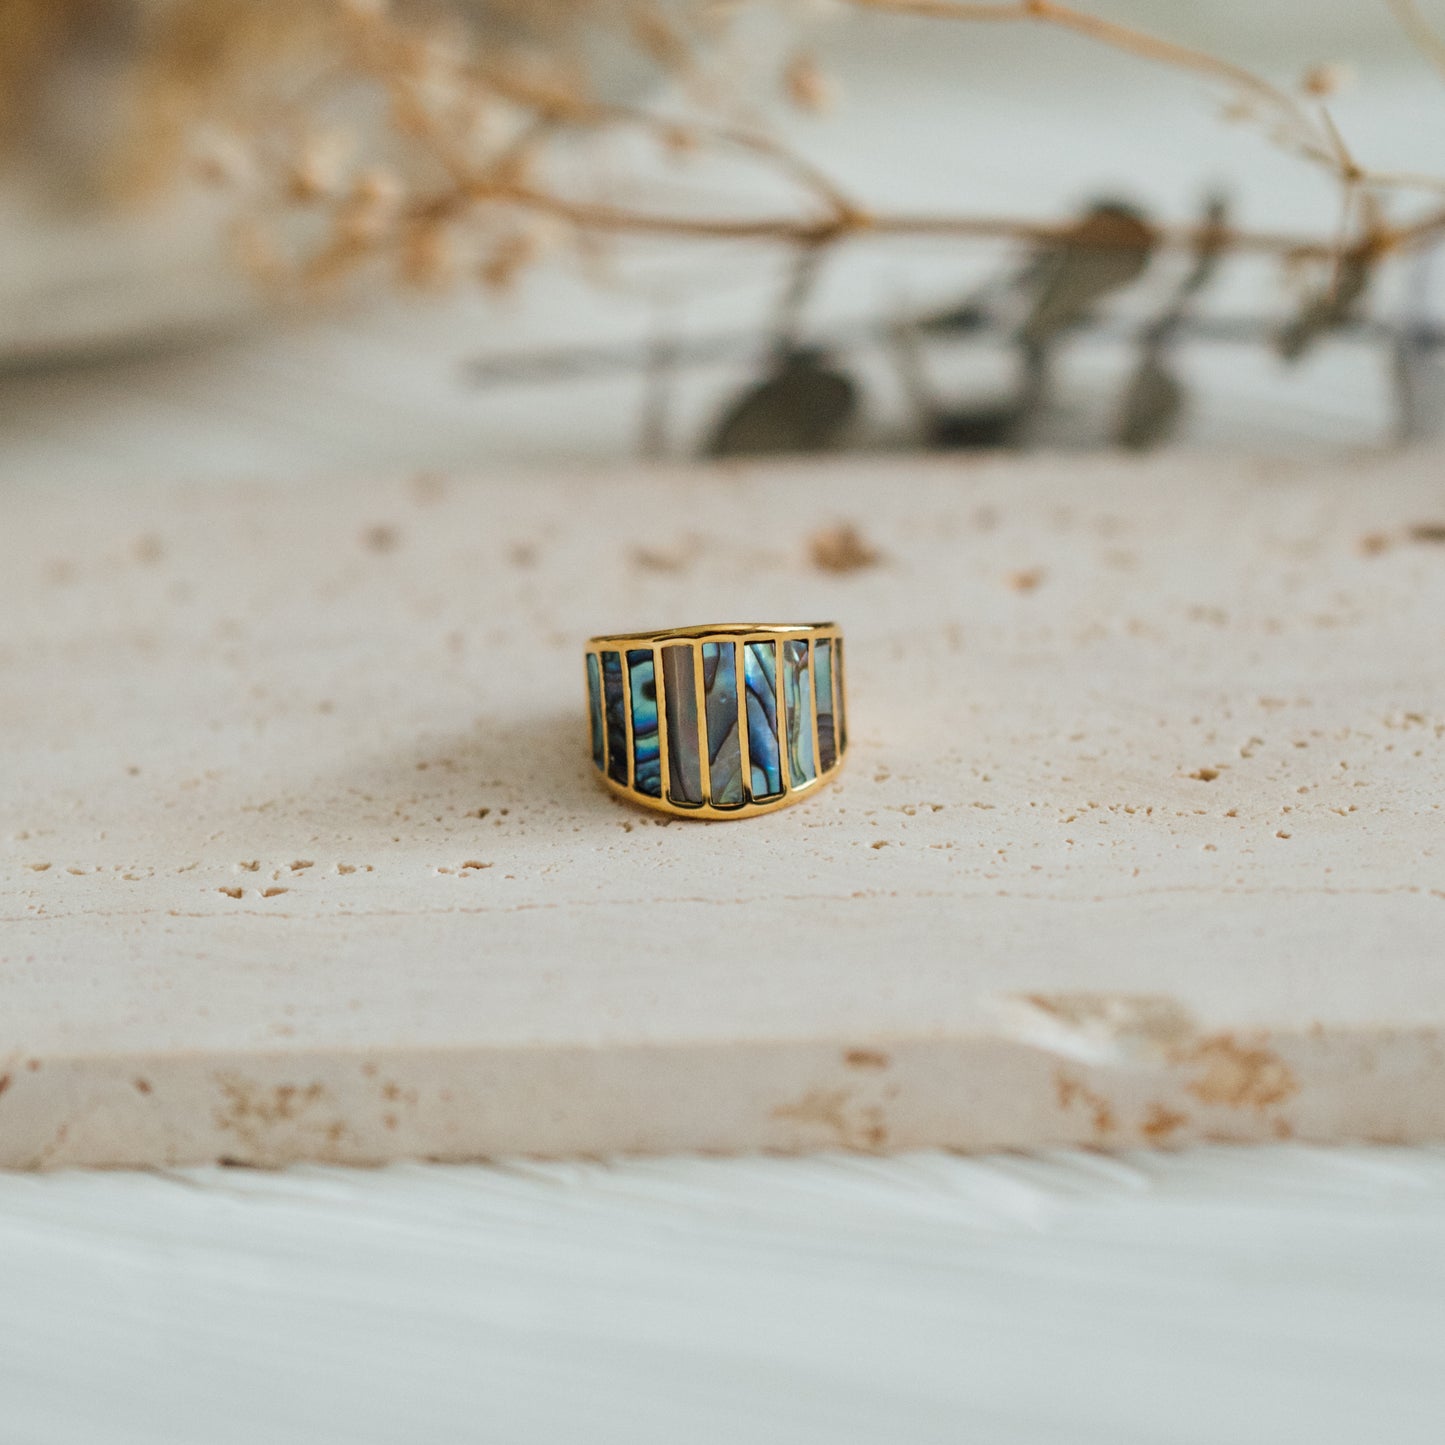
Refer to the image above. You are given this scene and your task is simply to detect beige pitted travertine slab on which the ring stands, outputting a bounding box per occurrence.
[0,455,1445,1166]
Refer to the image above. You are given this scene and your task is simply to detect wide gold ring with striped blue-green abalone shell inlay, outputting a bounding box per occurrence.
[587,623,848,818]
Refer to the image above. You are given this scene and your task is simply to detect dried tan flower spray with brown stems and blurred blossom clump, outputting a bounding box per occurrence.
[8,0,1445,286]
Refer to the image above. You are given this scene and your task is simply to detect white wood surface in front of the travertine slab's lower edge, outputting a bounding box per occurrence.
[0,1146,1445,1445]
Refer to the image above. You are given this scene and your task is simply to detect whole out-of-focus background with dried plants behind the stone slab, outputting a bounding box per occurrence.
[8,0,1445,483]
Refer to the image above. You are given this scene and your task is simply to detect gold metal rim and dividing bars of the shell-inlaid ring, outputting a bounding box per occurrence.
[582,621,847,822]
